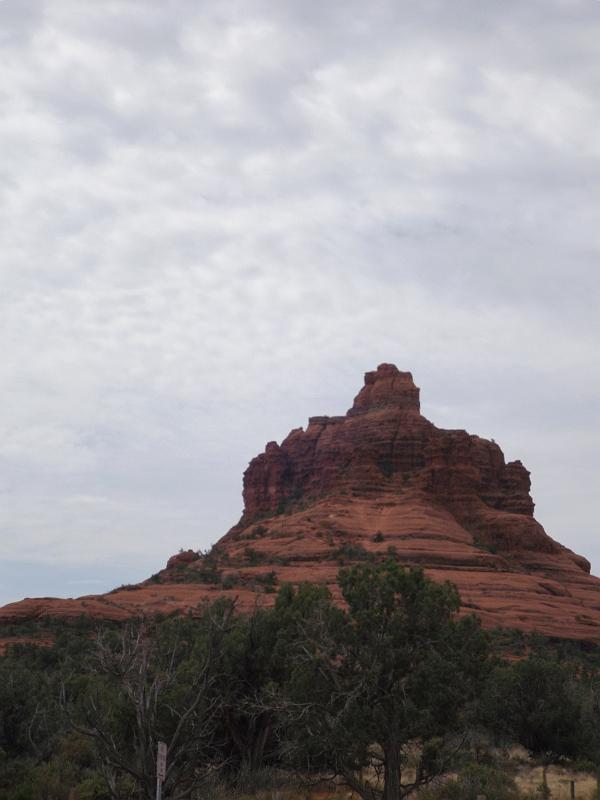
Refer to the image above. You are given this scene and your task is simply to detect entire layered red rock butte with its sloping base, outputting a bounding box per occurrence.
[0,364,600,642]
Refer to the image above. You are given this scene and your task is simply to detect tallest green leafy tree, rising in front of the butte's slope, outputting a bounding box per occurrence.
[287,561,488,800]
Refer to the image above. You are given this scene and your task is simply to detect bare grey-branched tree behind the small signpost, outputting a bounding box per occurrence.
[63,604,233,800]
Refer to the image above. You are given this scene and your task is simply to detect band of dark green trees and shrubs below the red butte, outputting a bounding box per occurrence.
[0,561,600,800]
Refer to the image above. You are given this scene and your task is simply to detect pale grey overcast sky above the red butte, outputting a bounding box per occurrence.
[0,0,600,604]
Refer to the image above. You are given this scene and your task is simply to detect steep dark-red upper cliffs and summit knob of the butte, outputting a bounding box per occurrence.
[234,364,561,552]
